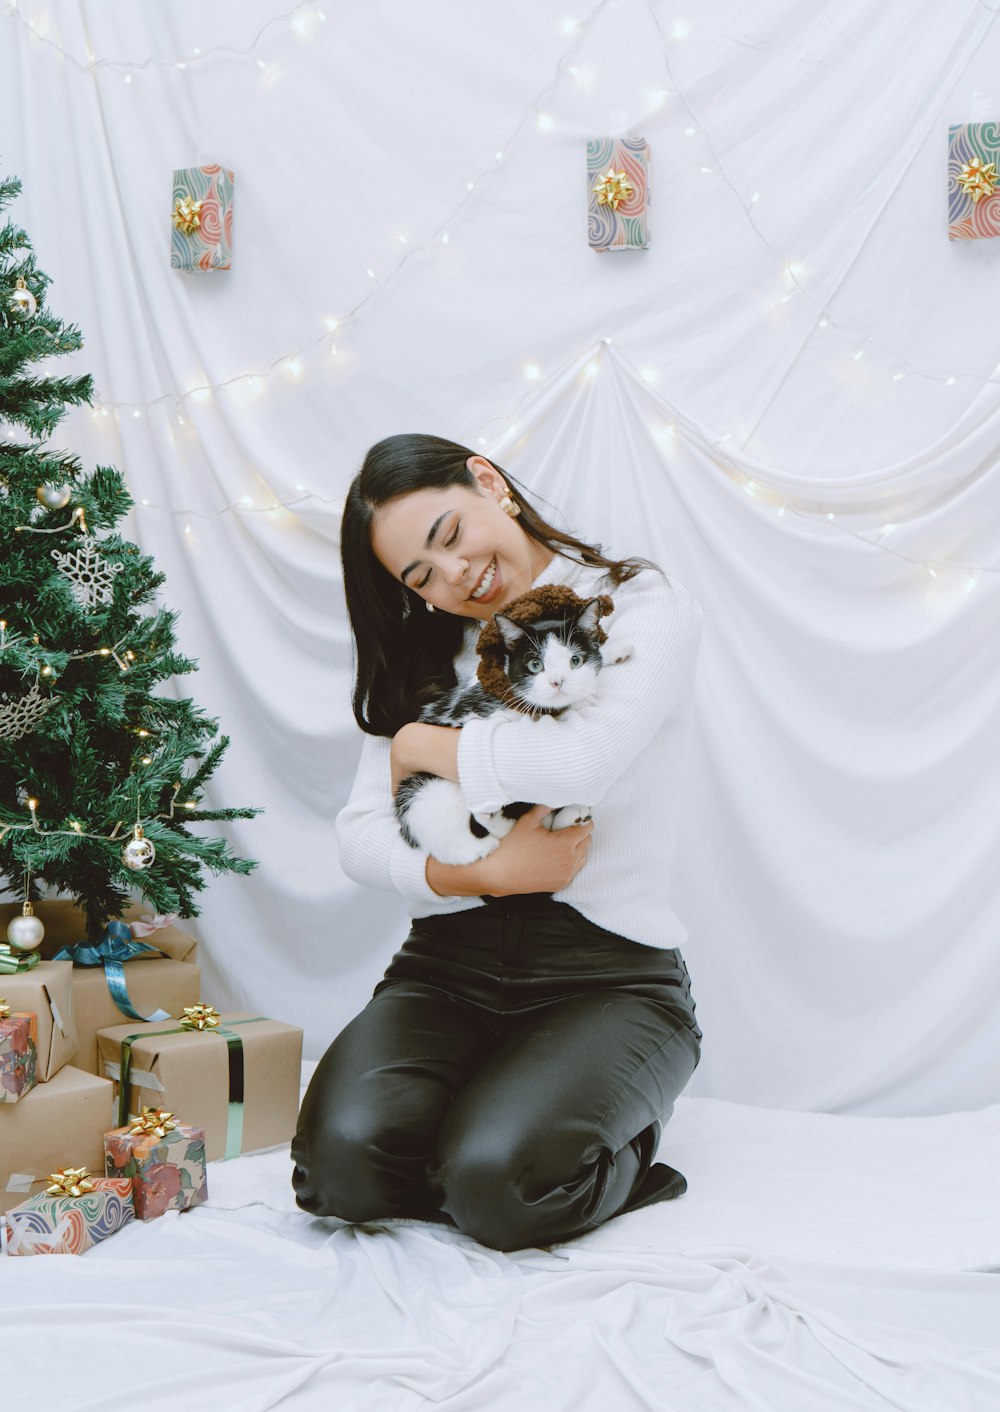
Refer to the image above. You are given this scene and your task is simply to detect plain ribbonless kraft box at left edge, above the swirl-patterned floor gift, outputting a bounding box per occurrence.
[0,1065,114,1213]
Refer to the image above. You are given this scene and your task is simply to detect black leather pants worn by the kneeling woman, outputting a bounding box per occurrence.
[292,894,702,1250]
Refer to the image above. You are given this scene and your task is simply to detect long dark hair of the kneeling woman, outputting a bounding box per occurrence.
[340,433,662,736]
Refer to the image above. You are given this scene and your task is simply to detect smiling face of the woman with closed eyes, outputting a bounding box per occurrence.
[371,456,552,621]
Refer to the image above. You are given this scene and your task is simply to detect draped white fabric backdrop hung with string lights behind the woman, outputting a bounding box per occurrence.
[0,0,1000,1114]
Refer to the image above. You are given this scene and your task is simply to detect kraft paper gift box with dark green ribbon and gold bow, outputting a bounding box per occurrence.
[97,1012,302,1162]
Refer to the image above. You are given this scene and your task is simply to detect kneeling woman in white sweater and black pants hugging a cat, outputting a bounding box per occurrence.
[292,435,702,1250]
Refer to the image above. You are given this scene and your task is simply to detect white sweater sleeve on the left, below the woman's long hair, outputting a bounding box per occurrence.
[335,734,468,912]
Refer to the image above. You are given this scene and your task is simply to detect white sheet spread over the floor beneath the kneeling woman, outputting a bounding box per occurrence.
[7,1099,1000,1412]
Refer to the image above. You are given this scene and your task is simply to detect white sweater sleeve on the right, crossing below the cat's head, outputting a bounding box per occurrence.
[458,569,702,813]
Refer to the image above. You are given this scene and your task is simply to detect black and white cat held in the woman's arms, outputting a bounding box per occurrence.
[395,599,603,863]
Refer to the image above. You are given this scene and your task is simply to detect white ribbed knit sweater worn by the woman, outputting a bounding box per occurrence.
[336,555,702,947]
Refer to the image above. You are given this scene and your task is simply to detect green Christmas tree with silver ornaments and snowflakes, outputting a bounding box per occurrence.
[0,178,260,940]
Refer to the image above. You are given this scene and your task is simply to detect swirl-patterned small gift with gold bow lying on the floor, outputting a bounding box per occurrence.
[6,1166,136,1255]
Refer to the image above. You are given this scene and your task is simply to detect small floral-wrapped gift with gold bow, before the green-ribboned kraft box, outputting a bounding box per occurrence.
[105,1108,208,1221]
